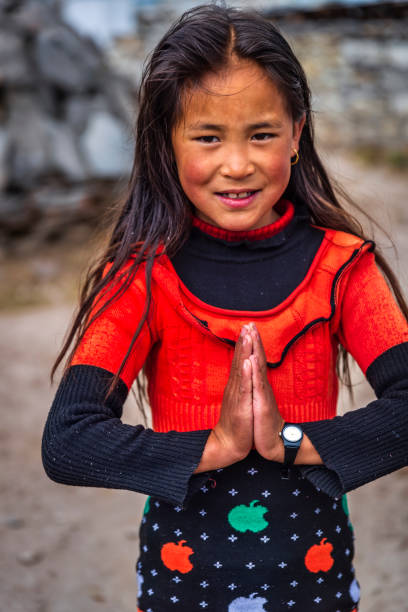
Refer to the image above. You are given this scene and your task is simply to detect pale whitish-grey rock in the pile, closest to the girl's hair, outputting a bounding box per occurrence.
[81,111,132,177]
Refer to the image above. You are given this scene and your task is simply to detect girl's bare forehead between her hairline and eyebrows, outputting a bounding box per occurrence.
[179,60,289,129]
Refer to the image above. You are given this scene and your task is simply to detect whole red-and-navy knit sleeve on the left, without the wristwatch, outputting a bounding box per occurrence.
[42,268,210,504]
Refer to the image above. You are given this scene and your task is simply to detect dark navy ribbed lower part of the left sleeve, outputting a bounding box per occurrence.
[42,366,209,503]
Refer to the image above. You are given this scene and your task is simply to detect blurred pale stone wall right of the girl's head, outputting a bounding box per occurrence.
[271,3,408,155]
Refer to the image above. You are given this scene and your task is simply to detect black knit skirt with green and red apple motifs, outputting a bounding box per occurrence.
[137,451,360,612]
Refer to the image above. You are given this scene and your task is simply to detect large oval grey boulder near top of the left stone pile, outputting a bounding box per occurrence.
[34,25,102,93]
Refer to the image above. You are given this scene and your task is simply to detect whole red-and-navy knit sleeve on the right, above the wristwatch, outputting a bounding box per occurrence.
[301,253,408,497]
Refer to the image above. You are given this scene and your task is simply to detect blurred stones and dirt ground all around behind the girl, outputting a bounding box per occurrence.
[0,0,408,612]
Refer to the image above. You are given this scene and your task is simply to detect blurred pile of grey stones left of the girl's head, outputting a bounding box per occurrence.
[0,0,136,249]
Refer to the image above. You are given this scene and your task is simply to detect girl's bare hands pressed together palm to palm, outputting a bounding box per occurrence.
[196,323,284,472]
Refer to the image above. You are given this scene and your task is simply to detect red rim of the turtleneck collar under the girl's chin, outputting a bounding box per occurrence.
[193,200,295,242]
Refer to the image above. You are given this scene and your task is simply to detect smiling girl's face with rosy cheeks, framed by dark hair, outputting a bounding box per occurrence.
[172,59,304,231]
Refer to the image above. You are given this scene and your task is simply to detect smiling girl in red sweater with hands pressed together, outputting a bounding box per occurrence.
[42,5,408,612]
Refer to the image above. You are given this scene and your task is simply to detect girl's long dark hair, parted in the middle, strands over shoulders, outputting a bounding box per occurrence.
[52,4,408,388]
